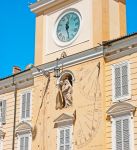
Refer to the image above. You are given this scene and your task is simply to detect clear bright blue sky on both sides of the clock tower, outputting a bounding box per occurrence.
[0,0,137,78]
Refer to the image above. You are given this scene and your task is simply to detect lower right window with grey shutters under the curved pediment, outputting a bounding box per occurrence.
[112,116,133,150]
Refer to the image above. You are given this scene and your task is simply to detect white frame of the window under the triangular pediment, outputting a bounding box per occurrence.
[57,125,73,150]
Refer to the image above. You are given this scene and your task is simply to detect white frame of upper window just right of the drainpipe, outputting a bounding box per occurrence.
[20,90,32,122]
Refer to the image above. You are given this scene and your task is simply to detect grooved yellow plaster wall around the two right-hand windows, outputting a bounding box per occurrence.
[105,53,137,150]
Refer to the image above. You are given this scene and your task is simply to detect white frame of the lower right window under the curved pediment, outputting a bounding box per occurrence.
[111,115,134,150]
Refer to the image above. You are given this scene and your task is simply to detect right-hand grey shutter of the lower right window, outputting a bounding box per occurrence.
[123,119,130,150]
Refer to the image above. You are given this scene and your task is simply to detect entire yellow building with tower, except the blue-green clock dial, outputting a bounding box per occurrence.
[0,0,137,150]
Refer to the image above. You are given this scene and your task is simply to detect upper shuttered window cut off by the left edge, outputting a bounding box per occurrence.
[0,100,6,124]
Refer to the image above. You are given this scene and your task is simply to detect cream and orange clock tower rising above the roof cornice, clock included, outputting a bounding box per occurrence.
[30,0,126,65]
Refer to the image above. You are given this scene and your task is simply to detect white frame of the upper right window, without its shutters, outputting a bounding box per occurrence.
[112,61,131,102]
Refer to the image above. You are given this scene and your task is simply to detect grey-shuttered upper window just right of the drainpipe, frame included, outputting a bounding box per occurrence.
[21,92,31,120]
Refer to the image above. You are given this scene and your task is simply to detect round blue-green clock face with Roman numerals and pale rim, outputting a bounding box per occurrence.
[56,11,81,44]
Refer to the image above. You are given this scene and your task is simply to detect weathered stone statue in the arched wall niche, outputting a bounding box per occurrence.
[56,78,72,109]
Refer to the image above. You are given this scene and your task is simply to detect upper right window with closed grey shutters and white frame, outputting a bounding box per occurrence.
[112,62,130,100]
